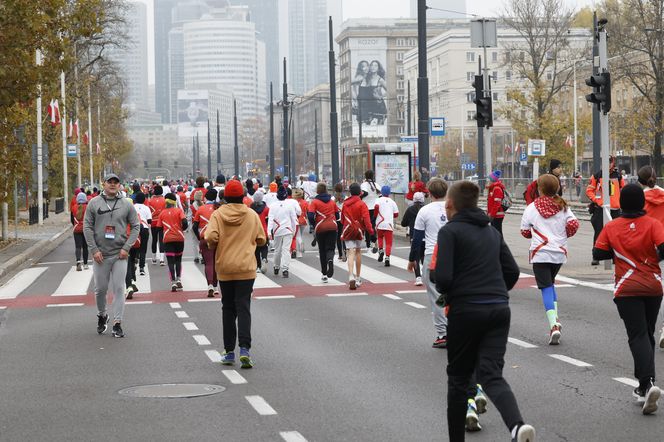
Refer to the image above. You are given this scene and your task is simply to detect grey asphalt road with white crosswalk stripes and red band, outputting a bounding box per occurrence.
[0,217,664,442]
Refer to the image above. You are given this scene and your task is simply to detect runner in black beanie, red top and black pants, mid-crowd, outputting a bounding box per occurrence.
[308,182,339,282]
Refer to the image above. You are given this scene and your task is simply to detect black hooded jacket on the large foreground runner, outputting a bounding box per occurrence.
[436,208,519,305]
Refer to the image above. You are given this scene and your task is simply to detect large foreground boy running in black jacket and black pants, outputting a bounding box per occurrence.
[436,181,535,442]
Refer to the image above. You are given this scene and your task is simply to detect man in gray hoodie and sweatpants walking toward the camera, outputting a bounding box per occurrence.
[83,173,141,338]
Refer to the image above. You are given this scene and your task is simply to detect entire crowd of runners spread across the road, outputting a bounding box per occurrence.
[70,160,664,442]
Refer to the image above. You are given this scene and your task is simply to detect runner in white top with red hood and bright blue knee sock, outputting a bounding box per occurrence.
[521,174,579,345]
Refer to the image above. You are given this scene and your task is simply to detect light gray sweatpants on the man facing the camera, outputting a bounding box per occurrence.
[92,255,127,323]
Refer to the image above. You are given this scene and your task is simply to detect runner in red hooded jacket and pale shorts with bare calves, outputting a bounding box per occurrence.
[341,183,373,290]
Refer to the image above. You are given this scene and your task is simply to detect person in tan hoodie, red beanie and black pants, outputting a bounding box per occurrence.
[205,180,266,368]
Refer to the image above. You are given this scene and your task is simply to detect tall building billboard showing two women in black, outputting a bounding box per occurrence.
[349,37,389,138]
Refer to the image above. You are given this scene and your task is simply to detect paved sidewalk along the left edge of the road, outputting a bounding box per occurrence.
[0,212,72,280]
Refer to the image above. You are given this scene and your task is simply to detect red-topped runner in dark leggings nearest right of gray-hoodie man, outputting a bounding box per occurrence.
[157,193,188,292]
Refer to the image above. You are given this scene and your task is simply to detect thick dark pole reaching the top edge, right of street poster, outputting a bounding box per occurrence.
[417,0,429,182]
